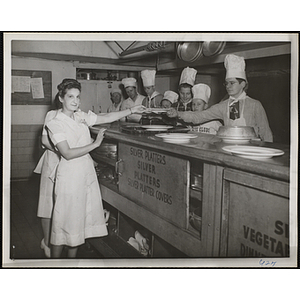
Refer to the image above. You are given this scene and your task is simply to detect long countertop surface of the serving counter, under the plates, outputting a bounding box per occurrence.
[91,122,290,181]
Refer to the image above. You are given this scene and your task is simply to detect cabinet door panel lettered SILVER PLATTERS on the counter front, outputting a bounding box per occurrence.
[119,144,188,227]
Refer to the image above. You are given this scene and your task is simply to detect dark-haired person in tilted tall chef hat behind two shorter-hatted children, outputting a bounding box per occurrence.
[175,67,197,111]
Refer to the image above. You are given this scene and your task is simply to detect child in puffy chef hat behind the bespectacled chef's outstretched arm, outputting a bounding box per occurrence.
[190,83,222,134]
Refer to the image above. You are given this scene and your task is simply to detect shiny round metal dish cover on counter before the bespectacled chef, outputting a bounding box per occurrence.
[216,126,257,144]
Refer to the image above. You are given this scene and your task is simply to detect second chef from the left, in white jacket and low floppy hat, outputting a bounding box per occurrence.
[121,77,145,123]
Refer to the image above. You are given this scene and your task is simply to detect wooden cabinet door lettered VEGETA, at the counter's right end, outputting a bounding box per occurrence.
[220,169,289,257]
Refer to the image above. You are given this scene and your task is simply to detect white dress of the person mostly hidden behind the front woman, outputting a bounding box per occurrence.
[34,110,59,219]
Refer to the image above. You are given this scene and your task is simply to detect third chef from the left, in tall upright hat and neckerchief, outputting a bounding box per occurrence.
[141,70,163,108]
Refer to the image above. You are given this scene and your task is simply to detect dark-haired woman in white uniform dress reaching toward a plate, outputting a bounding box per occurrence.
[46,79,144,258]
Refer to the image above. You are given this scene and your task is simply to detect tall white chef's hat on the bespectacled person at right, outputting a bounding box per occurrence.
[224,54,247,80]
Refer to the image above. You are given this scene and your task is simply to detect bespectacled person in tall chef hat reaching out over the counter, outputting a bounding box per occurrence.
[167,54,273,142]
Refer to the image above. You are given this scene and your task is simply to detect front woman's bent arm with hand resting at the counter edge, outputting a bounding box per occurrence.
[56,128,106,160]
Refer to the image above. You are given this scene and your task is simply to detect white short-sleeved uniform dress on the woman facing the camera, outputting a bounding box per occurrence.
[47,111,107,247]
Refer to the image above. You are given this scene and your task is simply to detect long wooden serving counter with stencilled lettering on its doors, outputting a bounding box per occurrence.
[91,123,290,258]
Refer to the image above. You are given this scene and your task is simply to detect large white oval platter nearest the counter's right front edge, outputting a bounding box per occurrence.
[223,146,284,159]
